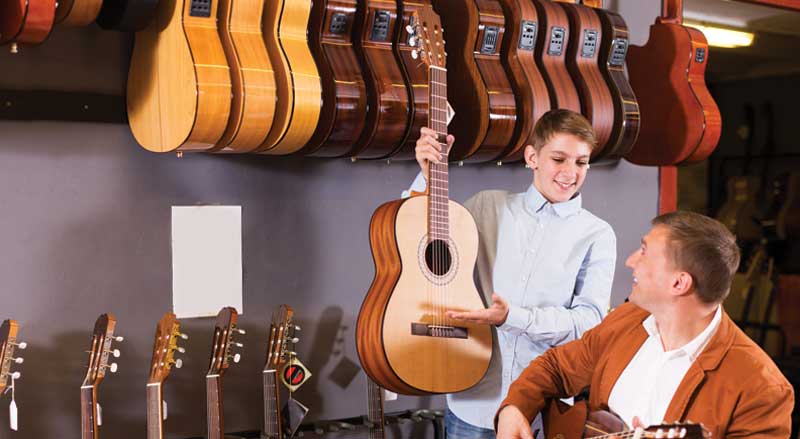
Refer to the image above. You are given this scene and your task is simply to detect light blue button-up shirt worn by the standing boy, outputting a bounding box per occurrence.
[402,173,617,428]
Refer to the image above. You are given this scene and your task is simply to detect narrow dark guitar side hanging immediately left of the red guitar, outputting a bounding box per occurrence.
[594,9,640,160]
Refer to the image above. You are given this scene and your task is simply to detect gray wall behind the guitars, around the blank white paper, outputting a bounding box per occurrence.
[0,1,658,439]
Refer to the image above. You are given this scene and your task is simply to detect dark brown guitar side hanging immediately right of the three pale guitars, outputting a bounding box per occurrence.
[304,0,367,157]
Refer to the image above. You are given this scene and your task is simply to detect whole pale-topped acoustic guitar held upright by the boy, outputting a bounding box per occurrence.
[356,8,492,395]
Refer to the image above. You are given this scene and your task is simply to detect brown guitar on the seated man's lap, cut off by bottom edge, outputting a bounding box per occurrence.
[542,400,711,439]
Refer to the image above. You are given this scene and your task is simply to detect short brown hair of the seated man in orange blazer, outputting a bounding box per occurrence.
[653,211,740,303]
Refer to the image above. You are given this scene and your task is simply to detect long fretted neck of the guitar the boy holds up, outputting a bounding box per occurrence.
[428,66,450,242]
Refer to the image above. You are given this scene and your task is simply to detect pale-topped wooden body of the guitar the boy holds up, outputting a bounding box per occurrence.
[356,196,492,395]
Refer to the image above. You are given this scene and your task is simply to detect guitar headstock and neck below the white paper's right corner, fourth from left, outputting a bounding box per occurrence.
[206,307,245,439]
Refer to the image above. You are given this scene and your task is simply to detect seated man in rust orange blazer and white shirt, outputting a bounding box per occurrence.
[496,212,794,439]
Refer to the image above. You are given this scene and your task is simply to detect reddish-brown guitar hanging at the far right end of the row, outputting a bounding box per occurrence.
[625,0,722,166]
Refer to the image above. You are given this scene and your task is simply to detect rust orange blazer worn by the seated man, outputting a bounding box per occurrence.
[495,303,794,439]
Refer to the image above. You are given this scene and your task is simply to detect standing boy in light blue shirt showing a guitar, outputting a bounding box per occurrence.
[411,110,616,439]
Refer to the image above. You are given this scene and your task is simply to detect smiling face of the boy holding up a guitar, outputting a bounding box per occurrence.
[525,133,592,203]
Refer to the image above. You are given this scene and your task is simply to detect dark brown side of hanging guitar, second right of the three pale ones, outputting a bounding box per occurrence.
[353,0,410,158]
